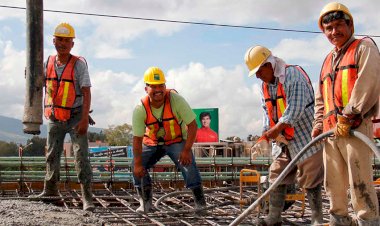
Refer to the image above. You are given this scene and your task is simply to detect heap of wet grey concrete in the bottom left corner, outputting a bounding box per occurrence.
[0,200,106,226]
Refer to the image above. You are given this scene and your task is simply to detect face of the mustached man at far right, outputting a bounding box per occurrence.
[322,19,353,49]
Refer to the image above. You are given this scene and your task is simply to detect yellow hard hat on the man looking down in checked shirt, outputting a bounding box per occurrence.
[244,46,272,77]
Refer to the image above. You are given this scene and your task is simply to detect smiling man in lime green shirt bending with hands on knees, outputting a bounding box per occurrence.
[132,67,206,213]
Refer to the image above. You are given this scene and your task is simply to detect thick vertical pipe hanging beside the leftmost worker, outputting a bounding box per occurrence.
[22,0,44,134]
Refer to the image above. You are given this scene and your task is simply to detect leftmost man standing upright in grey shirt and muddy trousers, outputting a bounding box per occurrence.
[29,23,95,211]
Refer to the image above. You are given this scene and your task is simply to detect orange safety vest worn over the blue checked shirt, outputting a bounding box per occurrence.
[262,65,312,140]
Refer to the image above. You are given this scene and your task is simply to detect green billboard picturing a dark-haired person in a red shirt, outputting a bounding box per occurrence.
[193,108,219,143]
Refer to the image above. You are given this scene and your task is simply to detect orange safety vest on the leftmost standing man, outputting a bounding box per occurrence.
[45,55,79,121]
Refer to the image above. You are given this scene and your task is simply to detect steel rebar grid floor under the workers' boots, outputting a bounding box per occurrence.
[0,184,342,226]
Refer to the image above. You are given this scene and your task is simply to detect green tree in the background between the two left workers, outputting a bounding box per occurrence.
[104,123,133,146]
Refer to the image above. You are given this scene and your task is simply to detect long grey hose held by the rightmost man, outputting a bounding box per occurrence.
[229,130,380,226]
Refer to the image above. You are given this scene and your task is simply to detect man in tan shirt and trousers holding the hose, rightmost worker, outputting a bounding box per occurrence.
[312,2,380,226]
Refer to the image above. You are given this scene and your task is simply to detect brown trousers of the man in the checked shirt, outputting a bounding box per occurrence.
[269,147,323,189]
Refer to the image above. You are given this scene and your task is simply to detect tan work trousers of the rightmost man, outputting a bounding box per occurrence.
[323,119,379,220]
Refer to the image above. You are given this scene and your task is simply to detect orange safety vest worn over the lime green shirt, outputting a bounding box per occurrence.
[141,89,182,146]
